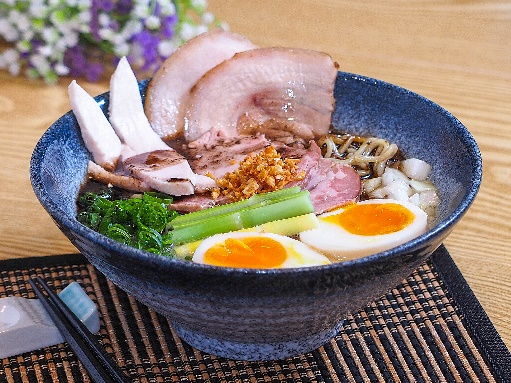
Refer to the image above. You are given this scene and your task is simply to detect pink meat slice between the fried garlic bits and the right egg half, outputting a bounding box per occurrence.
[286,141,361,214]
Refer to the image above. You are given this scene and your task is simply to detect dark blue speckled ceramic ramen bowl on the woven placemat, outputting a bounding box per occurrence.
[30,72,482,360]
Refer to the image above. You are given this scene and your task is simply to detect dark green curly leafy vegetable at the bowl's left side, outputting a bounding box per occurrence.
[77,189,178,256]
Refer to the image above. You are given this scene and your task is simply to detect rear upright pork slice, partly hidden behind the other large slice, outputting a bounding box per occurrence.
[145,28,257,139]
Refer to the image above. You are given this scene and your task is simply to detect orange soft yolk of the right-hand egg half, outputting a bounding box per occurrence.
[322,203,415,236]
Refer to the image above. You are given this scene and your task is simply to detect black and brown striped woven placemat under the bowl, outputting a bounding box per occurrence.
[0,247,511,382]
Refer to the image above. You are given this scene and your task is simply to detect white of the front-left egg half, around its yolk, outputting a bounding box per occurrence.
[192,232,331,268]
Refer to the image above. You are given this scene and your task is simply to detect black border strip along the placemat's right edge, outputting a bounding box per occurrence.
[431,245,511,382]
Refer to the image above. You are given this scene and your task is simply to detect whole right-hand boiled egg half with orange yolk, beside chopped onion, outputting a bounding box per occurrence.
[300,199,428,261]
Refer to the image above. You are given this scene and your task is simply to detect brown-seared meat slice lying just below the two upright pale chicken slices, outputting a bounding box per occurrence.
[123,149,216,196]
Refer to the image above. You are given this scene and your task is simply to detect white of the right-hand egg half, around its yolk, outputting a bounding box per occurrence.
[300,199,428,261]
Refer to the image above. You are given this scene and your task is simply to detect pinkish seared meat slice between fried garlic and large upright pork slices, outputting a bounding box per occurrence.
[180,129,270,178]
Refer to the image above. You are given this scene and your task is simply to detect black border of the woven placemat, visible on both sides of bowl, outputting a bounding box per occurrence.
[0,245,511,382]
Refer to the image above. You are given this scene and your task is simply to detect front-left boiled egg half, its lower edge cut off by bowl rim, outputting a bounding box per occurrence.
[192,232,331,269]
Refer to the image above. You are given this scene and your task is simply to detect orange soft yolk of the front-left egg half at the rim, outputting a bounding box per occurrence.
[204,237,287,269]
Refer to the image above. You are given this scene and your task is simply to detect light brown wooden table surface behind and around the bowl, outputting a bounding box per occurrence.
[0,0,511,354]
